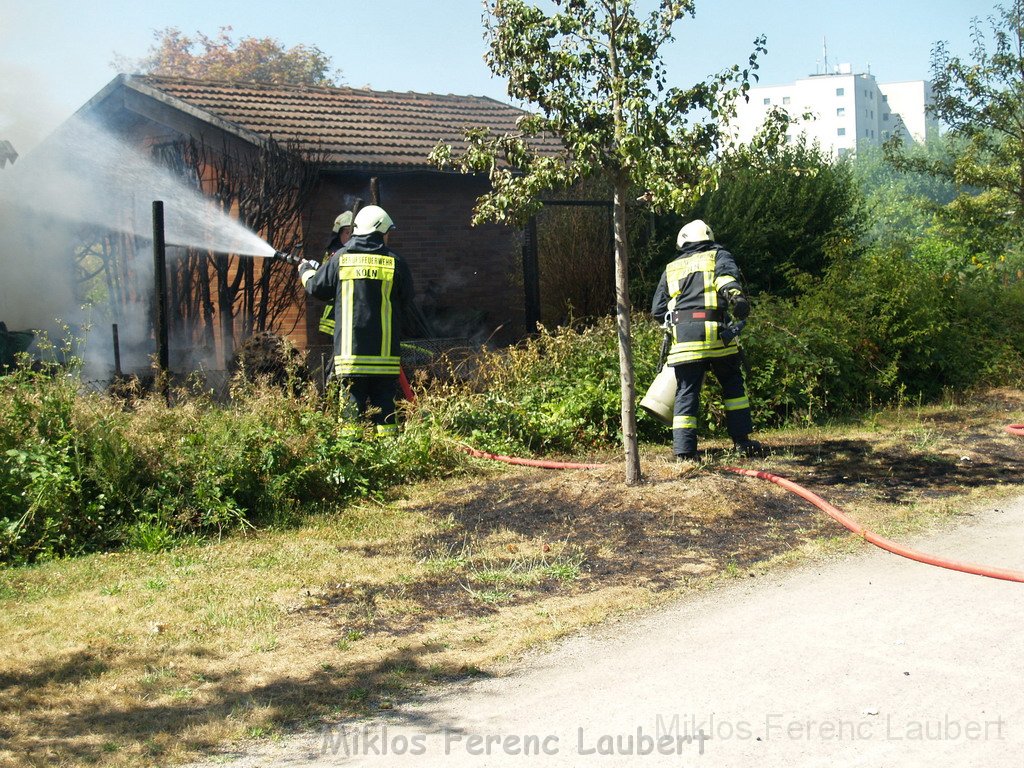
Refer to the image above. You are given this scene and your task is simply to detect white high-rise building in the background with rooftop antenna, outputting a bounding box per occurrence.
[733,65,938,157]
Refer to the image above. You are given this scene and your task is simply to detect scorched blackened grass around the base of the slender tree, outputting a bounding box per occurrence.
[309,392,1024,647]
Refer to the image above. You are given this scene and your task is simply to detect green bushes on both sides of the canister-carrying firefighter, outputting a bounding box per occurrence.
[428,243,1024,456]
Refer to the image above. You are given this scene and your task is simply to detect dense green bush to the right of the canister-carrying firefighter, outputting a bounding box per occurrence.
[744,251,1024,426]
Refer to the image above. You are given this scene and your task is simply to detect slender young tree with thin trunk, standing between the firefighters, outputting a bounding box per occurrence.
[434,0,765,484]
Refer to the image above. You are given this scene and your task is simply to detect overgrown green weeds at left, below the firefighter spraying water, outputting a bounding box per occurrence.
[0,360,453,562]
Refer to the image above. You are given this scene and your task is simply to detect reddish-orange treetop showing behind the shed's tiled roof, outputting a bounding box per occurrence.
[114,27,341,86]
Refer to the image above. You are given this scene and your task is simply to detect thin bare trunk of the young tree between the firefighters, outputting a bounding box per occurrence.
[614,178,643,485]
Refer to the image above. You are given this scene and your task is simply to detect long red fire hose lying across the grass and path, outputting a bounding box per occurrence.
[399,371,1024,584]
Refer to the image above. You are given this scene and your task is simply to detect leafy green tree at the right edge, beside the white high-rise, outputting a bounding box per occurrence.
[886,0,1024,256]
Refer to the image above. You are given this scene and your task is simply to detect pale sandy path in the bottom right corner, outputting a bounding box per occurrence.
[193,498,1024,768]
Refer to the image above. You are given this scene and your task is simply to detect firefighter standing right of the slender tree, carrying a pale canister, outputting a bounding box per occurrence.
[651,219,764,461]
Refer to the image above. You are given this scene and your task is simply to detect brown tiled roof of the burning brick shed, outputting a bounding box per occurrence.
[132,76,557,169]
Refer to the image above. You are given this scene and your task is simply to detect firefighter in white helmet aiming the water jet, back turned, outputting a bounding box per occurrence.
[298,206,413,435]
